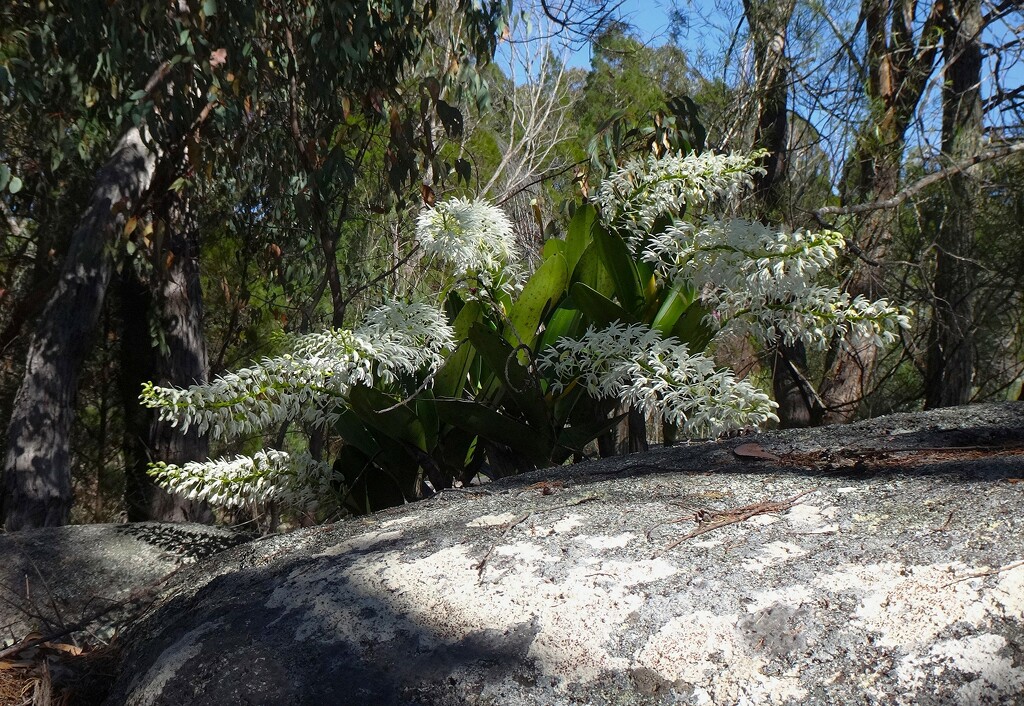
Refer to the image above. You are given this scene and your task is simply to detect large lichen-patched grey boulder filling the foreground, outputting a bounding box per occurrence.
[108,404,1024,706]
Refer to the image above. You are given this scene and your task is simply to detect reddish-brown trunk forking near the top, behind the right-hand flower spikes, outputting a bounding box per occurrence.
[820,0,943,422]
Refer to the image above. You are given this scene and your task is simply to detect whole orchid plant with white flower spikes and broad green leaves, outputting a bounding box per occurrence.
[142,145,909,511]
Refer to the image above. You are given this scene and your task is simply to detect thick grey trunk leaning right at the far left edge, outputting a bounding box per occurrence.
[0,127,158,530]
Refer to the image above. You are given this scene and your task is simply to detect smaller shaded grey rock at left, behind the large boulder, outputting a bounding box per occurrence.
[0,523,246,646]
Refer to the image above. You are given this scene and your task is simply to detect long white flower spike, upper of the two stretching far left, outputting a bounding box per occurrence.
[141,302,455,438]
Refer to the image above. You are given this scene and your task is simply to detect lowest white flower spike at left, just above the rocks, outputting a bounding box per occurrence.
[150,449,333,510]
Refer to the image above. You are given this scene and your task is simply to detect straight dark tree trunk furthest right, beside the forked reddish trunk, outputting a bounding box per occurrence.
[925,0,982,408]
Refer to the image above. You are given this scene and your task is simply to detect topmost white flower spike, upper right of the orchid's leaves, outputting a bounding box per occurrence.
[597,152,764,241]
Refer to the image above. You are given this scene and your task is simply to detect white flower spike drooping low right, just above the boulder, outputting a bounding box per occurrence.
[539,323,777,437]
